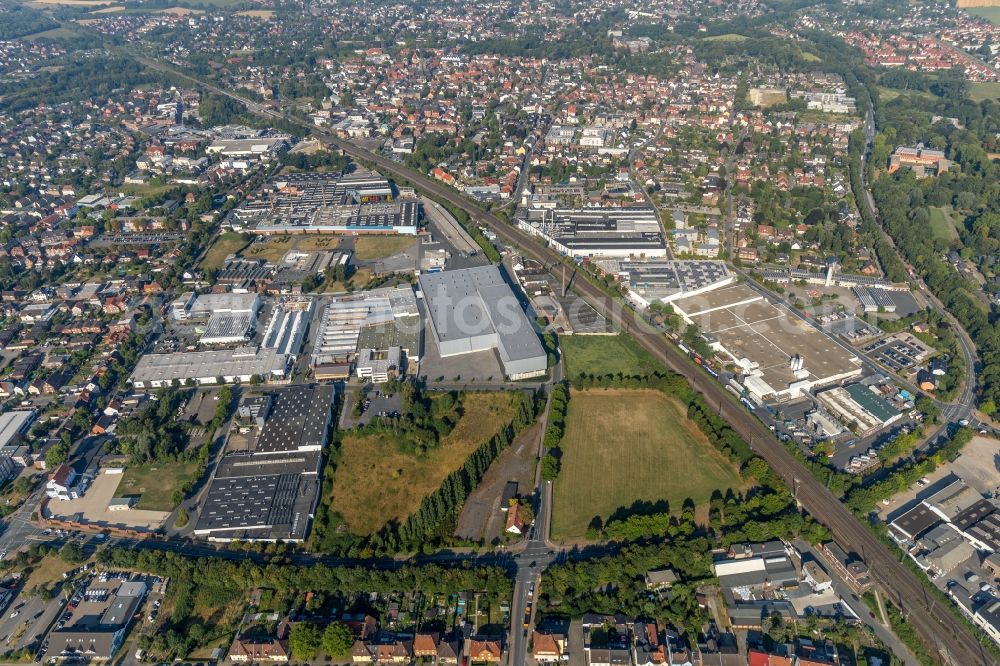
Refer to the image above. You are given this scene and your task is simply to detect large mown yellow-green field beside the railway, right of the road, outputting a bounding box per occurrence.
[552,390,745,539]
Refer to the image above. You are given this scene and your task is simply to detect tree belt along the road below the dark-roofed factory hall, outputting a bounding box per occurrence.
[99,548,512,659]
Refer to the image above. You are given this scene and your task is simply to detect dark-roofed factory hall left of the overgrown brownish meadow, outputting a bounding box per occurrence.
[194,385,335,542]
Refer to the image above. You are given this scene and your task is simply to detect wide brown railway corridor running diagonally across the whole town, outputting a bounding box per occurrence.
[133,54,994,666]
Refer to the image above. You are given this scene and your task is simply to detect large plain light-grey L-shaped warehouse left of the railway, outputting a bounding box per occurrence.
[420,265,548,379]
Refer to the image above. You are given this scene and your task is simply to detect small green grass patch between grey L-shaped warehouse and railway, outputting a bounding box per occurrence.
[559,334,663,379]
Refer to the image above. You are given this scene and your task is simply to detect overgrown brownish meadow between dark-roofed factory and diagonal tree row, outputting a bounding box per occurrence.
[330,391,514,535]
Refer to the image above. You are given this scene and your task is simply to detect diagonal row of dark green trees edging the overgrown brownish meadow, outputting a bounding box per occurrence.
[370,391,537,552]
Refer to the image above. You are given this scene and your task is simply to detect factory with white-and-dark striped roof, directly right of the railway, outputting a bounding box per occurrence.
[517,205,667,258]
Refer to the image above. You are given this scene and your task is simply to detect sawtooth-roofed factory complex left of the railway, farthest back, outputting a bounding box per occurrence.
[224,171,420,236]
